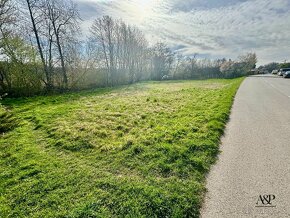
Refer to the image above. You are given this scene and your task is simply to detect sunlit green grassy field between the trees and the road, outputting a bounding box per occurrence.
[0,79,242,217]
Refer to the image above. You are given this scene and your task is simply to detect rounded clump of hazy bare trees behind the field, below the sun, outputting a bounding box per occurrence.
[91,16,148,86]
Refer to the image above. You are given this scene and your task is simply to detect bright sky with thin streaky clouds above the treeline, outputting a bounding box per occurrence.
[75,0,290,65]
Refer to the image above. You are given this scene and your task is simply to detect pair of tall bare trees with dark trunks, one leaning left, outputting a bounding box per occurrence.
[22,0,80,89]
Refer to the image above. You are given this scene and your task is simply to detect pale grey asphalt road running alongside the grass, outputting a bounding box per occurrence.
[201,75,290,218]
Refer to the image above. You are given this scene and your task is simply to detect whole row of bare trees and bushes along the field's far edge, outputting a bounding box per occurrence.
[0,0,257,95]
